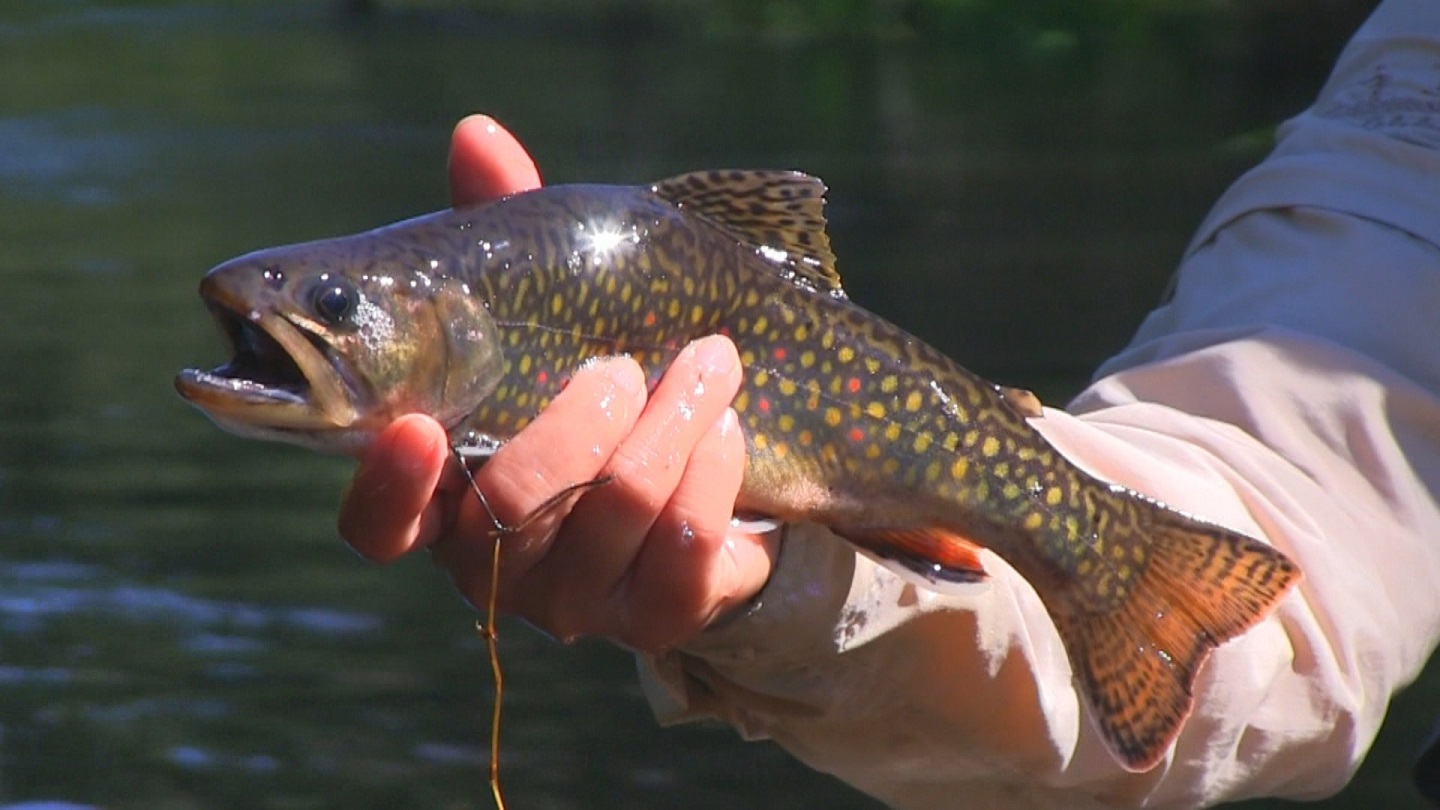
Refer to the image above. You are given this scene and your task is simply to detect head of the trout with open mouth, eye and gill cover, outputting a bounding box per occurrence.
[176,229,504,455]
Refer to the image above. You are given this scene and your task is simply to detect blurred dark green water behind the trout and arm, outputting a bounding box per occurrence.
[0,0,1440,810]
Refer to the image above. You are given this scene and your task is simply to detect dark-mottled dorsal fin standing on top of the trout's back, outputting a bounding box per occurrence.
[649,170,845,297]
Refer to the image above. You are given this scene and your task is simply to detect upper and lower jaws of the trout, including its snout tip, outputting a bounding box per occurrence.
[176,257,376,454]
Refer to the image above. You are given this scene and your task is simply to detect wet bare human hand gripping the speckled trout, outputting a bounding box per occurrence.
[340,115,776,650]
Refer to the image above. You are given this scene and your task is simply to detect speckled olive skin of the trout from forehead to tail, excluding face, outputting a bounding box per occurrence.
[177,172,1299,771]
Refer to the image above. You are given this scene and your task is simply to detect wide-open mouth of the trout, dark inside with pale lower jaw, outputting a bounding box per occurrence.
[176,300,359,432]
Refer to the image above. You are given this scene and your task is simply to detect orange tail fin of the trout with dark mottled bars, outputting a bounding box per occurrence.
[1051,493,1300,771]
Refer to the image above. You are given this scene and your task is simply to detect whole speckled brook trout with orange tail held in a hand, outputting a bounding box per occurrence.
[176,170,1300,773]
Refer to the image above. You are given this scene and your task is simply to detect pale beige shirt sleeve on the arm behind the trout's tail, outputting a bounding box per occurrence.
[641,0,1440,810]
